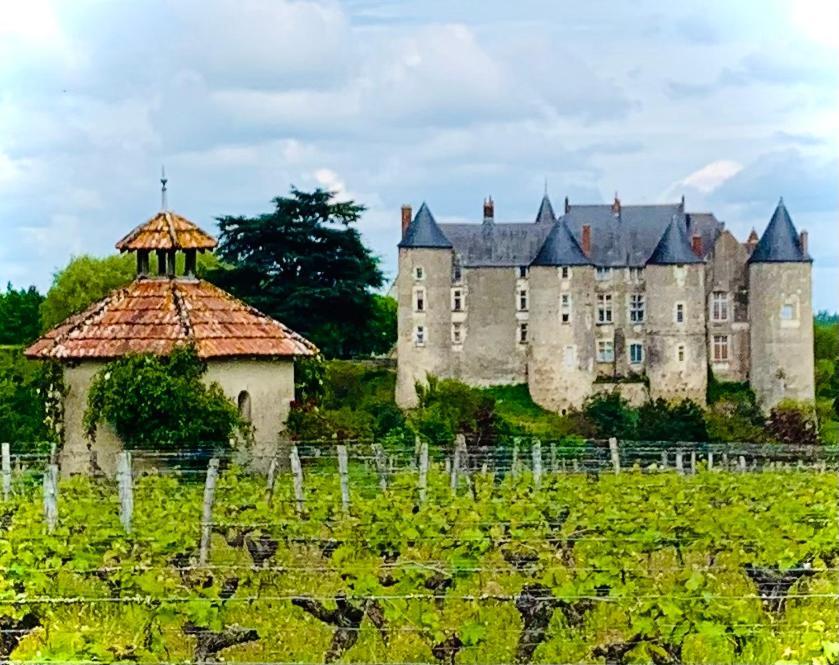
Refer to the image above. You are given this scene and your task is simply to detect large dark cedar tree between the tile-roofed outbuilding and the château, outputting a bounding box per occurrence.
[212,188,383,357]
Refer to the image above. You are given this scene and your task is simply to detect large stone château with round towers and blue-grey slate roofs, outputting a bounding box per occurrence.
[396,194,814,411]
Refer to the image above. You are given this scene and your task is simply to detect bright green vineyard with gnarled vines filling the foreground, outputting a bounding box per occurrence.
[0,446,839,665]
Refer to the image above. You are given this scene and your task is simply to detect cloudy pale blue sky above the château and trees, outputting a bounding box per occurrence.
[0,0,839,311]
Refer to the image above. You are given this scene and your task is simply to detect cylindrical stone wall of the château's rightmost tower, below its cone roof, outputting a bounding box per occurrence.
[749,263,815,410]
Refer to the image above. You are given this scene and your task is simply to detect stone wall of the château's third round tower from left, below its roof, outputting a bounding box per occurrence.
[645,264,708,404]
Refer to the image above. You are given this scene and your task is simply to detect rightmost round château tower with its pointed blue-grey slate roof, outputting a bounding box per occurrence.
[749,199,815,411]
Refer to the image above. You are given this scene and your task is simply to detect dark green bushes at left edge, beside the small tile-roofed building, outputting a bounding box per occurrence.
[0,347,54,452]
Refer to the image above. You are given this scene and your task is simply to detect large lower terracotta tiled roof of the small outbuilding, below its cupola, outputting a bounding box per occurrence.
[26,278,317,360]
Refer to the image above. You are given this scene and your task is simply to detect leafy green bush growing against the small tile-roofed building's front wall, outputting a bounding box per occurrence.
[84,346,247,450]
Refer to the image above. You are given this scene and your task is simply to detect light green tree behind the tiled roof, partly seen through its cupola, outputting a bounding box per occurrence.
[41,254,223,330]
